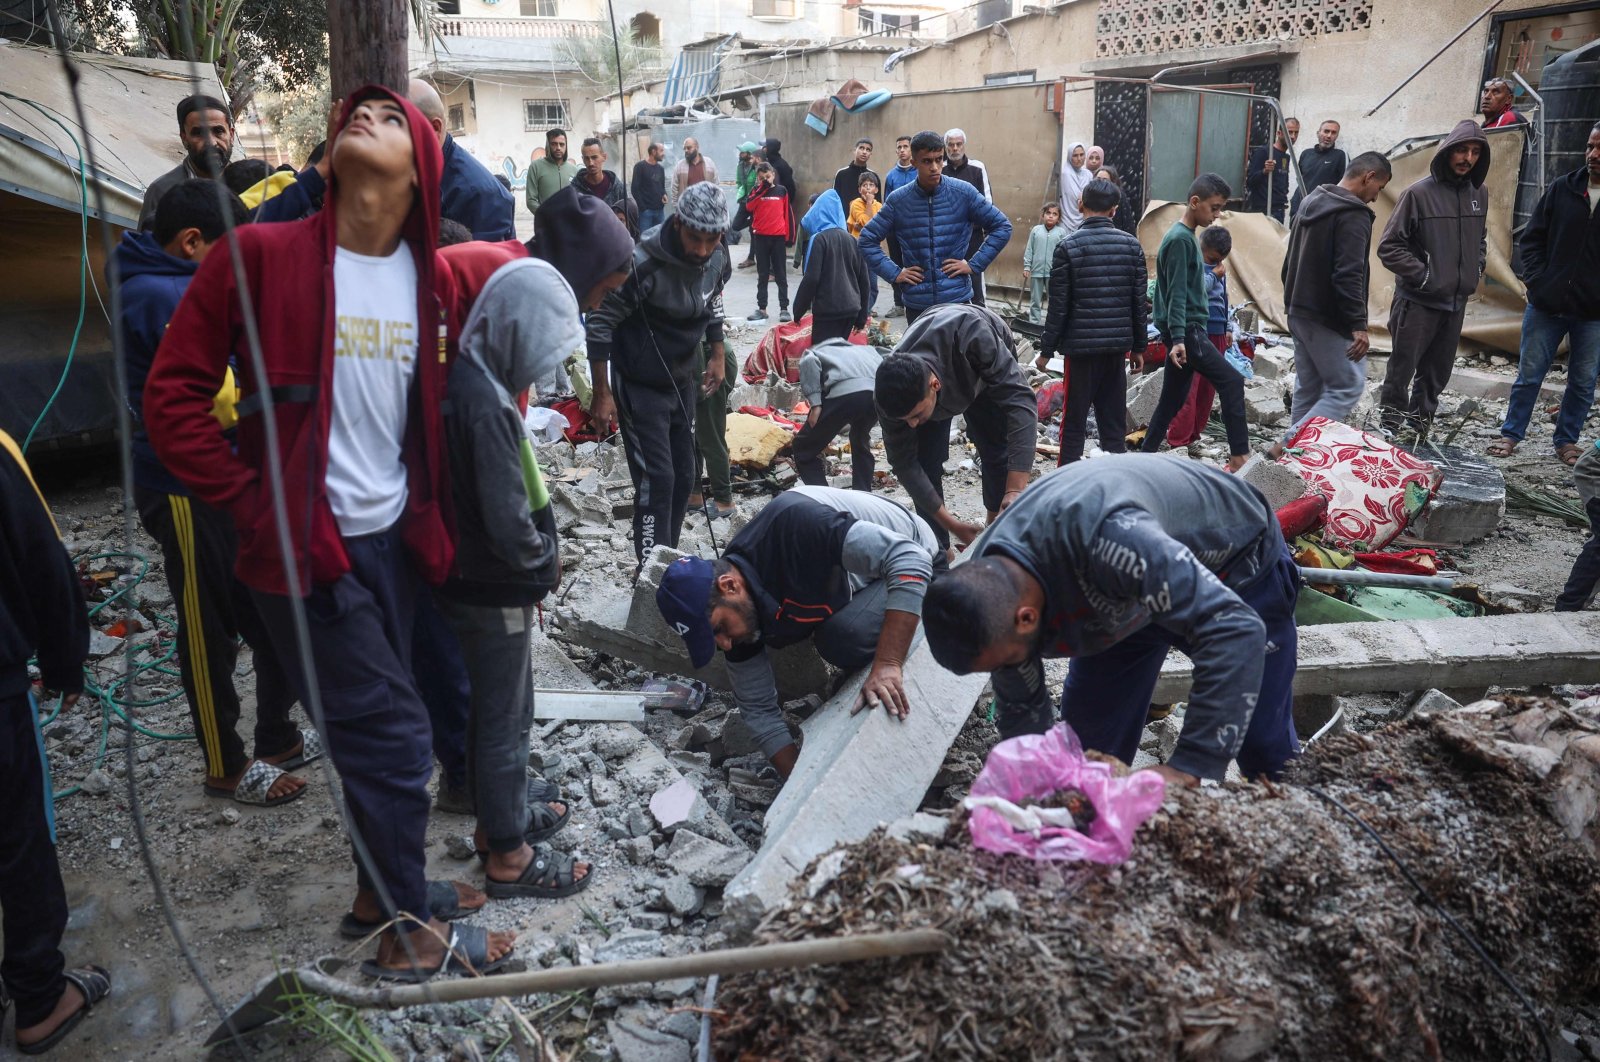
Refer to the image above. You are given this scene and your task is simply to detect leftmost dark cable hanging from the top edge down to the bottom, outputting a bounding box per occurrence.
[36,0,245,1054]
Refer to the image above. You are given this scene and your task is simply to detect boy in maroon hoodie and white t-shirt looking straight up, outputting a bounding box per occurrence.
[144,86,512,980]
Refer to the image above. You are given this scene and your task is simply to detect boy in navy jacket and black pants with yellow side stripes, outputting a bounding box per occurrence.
[115,181,320,806]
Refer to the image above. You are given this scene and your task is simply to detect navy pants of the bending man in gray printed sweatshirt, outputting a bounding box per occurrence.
[1061,547,1301,777]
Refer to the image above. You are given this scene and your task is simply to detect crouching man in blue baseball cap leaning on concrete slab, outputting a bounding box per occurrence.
[656,486,944,777]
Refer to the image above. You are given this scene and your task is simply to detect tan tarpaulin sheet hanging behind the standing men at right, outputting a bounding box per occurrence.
[1139,126,1529,355]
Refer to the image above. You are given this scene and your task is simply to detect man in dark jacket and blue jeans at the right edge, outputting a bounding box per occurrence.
[1490,123,1600,464]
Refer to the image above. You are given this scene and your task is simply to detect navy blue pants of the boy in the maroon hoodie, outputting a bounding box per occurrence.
[256,528,434,929]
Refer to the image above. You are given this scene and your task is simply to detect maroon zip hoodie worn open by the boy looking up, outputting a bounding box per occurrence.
[144,85,454,593]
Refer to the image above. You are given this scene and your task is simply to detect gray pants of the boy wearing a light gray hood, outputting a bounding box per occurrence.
[437,598,533,852]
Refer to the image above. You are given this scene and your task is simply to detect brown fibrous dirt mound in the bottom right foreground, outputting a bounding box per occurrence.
[717,699,1600,1060]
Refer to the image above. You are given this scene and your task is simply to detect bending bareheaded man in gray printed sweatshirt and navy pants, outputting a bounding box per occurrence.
[923,454,1299,785]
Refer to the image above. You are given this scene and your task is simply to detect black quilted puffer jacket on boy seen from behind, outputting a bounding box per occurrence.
[1040,218,1149,357]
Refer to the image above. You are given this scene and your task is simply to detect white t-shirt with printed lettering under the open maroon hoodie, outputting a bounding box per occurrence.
[326,242,418,537]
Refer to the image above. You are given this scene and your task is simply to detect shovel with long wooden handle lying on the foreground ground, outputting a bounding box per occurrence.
[205,929,952,1048]
